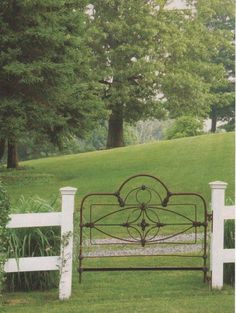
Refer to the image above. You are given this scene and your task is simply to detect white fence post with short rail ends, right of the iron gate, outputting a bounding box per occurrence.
[209,181,235,289]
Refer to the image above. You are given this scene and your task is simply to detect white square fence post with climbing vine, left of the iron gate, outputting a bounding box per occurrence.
[59,187,77,300]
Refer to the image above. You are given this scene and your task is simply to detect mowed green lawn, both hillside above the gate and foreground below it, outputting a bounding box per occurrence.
[0,133,234,313]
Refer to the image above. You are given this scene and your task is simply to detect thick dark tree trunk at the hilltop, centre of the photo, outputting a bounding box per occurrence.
[107,108,124,149]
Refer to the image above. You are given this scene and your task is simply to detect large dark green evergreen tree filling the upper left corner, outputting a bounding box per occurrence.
[0,0,102,168]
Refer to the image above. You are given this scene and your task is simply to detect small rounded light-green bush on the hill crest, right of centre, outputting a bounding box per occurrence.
[166,116,203,139]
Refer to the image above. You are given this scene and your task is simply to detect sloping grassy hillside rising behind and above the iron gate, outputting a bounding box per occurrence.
[0,133,234,202]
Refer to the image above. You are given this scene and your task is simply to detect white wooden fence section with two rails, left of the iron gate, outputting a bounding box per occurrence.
[4,187,77,300]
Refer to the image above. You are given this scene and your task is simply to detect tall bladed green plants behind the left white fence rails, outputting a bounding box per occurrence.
[5,197,60,291]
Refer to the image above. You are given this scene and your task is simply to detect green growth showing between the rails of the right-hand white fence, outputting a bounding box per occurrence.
[224,220,235,285]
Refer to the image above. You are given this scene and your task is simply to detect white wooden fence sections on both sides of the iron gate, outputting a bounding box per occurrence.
[4,181,235,300]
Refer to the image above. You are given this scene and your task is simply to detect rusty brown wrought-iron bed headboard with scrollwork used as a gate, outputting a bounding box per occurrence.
[78,174,210,282]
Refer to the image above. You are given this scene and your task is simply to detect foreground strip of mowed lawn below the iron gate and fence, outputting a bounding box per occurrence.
[2,266,234,313]
